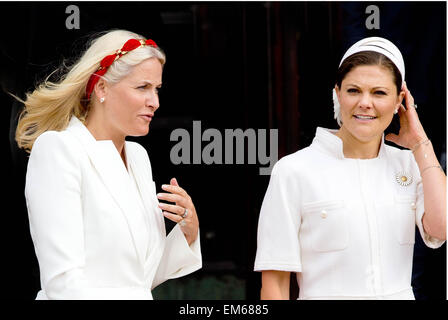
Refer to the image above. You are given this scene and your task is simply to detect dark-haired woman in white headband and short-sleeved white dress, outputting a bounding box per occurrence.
[254,37,446,299]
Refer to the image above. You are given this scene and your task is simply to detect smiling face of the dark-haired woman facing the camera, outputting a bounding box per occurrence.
[335,66,404,142]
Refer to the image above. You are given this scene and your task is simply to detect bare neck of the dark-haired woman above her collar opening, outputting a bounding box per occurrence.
[335,126,382,159]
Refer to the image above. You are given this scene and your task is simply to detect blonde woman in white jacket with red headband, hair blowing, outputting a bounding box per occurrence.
[16,30,202,300]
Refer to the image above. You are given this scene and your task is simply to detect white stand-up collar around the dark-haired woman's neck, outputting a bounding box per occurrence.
[311,127,386,160]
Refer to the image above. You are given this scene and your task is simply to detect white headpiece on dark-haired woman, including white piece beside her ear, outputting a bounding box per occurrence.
[333,37,405,126]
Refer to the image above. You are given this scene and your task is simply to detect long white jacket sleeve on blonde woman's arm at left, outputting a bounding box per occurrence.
[25,131,91,299]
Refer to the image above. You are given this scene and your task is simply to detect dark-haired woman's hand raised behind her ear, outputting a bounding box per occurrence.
[385,82,428,149]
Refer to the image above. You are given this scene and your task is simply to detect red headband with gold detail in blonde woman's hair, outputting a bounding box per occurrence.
[86,39,157,100]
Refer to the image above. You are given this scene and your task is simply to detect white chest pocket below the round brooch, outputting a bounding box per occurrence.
[389,195,416,245]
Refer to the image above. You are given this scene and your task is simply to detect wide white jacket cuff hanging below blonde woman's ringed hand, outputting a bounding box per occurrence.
[151,225,202,289]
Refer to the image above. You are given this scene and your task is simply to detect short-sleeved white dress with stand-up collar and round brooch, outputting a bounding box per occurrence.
[254,128,444,299]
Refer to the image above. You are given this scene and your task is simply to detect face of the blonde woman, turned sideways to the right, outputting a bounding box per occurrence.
[100,58,162,136]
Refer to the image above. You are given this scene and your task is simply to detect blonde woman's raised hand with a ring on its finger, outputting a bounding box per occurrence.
[157,178,199,245]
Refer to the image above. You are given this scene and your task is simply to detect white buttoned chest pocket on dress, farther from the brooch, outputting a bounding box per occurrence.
[302,200,349,252]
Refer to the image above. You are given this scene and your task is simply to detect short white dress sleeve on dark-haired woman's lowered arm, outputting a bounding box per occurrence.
[254,160,302,272]
